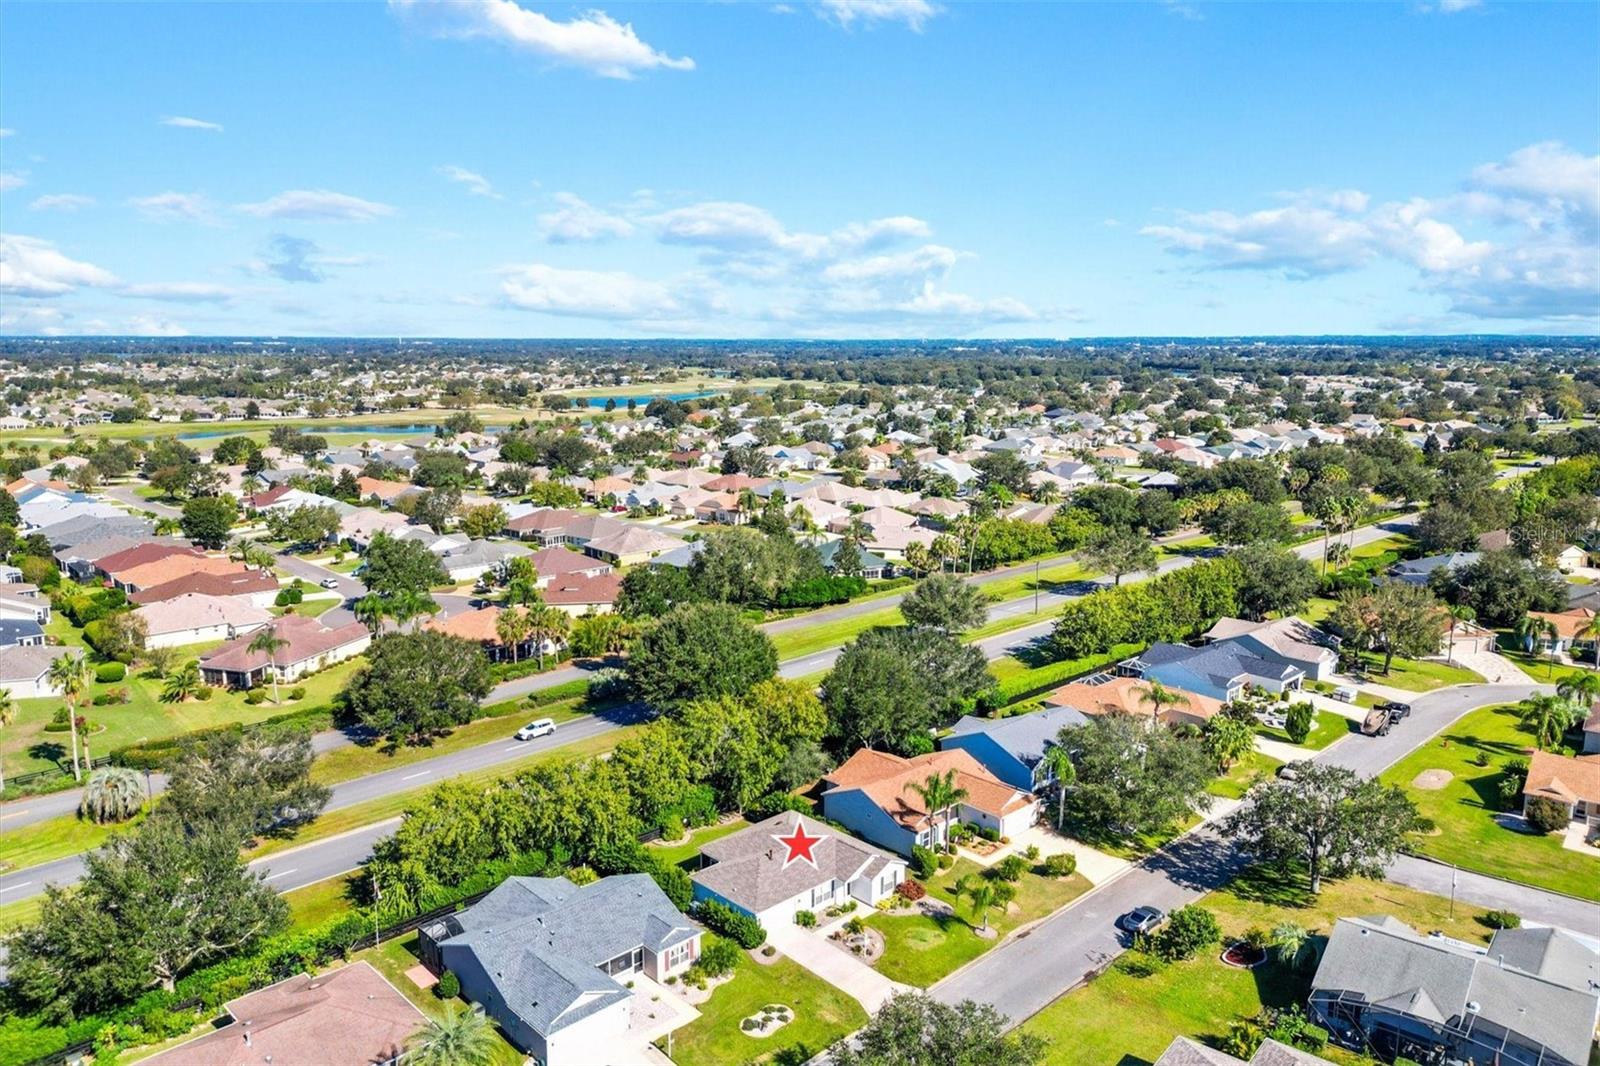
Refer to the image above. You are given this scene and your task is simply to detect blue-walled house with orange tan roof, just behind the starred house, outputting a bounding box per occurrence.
[822,747,1038,855]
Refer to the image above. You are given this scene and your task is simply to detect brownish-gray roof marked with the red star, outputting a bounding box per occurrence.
[694,810,901,914]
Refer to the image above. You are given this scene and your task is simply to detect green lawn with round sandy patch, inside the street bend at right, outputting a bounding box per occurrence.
[1382,707,1600,901]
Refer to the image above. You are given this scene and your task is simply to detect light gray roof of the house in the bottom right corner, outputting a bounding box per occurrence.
[1312,916,1600,1063]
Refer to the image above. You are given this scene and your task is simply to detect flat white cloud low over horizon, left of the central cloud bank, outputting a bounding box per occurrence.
[501,262,715,323]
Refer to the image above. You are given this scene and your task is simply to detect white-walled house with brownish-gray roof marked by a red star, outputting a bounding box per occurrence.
[691,812,906,927]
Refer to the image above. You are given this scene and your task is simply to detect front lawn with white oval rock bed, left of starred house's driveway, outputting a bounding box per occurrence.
[672,933,867,1066]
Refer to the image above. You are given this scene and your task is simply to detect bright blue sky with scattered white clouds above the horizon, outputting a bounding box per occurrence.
[0,0,1600,338]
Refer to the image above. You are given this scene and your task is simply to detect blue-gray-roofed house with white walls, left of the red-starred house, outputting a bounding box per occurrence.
[419,874,701,1066]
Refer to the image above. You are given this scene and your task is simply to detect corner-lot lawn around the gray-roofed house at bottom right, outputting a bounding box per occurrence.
[1024,871,1490,1066]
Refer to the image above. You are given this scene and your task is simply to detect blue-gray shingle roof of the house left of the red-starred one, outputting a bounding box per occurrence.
[429,874,699,1036]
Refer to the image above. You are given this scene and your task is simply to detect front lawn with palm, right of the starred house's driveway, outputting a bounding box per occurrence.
[867,860,1090,988]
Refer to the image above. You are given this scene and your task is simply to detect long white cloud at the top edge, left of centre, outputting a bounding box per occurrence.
[389,0,694,78]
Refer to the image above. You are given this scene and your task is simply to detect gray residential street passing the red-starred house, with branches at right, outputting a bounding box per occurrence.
[931,685,1600,1023]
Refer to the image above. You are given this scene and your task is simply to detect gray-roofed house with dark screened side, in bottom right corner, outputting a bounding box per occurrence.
[1310,916,1600,1066]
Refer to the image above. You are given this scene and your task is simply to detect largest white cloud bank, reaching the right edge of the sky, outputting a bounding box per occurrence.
[1141,142,1600,319]
